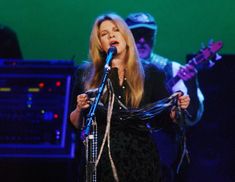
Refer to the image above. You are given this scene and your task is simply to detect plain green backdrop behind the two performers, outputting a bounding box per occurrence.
[0,0,235,63]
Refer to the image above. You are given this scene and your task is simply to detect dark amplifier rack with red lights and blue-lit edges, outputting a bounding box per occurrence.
[0,60,74,158]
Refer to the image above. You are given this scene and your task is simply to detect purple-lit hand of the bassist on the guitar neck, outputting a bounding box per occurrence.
[177,64,197,81]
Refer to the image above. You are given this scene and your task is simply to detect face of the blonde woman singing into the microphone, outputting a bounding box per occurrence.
[99,20,127,54]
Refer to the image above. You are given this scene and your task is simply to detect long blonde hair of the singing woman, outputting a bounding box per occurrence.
[85,13,145,108]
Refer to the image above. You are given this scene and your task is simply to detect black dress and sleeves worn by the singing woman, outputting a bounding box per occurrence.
[72,61,170,182]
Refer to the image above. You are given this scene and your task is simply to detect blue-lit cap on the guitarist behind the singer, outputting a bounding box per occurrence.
[125,12,157,30]
